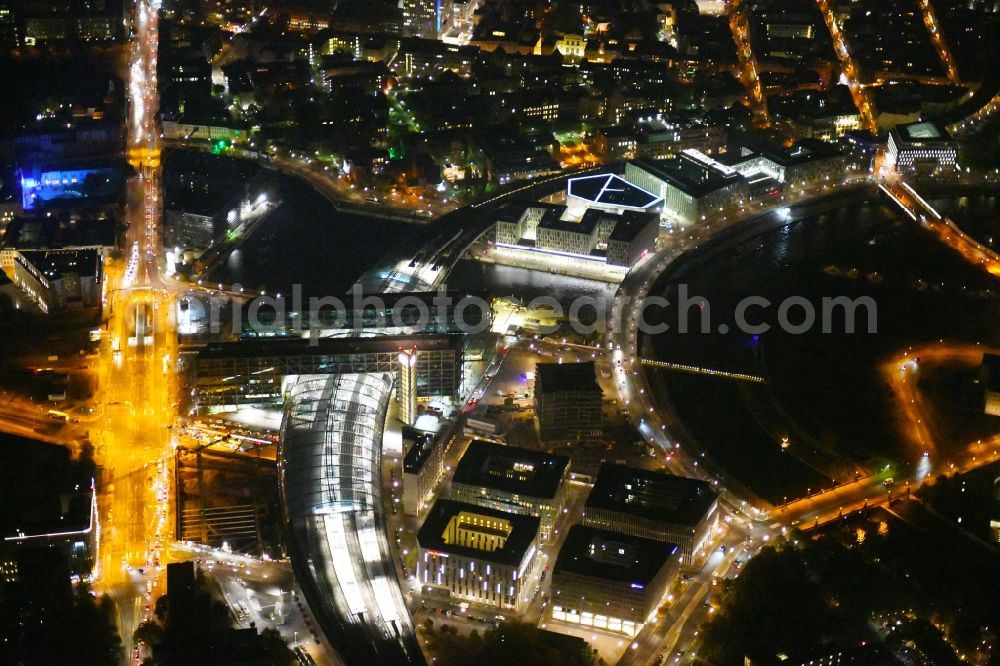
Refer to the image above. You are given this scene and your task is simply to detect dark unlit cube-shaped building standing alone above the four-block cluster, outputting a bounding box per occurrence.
[535,362,603,441]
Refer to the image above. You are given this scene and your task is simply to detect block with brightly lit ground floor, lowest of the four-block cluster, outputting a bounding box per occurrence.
[550,525,680,636]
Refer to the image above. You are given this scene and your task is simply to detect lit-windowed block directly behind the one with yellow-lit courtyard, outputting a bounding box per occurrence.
[451,440,569,541]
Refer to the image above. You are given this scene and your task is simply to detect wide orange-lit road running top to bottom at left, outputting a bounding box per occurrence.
[94,0,177,660]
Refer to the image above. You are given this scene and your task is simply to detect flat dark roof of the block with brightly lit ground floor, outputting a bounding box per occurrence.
[553,525,678,589]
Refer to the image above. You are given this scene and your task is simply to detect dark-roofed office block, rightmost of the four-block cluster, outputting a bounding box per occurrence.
[583,463,719,567]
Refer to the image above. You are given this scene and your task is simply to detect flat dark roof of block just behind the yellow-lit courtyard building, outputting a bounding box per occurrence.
[452,439,569,499]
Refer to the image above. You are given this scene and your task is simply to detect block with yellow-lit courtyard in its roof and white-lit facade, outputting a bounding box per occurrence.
[417,500,539,612]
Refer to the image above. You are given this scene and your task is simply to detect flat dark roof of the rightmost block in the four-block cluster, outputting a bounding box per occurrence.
[585,463,718,527]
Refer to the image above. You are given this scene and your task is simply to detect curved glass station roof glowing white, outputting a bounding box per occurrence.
[281,373,423,664]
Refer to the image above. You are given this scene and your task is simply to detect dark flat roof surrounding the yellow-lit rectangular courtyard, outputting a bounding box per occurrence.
[417,499,540,566]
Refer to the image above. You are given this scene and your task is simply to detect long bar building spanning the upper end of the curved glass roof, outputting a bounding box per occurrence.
[189,335,462,412]
